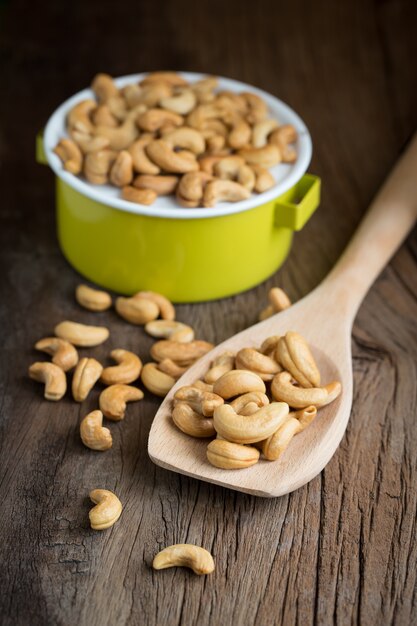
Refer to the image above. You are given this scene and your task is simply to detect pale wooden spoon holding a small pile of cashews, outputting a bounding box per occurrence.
[148,136,417,497]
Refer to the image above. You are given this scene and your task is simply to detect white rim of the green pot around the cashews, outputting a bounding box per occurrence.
[44,72,312,219]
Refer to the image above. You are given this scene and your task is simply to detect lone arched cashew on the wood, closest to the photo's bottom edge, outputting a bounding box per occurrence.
[152,543,214,574]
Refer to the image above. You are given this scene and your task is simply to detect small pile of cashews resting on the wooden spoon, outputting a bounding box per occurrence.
[172,331,342,470]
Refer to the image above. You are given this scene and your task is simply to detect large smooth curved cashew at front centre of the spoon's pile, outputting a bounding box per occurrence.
[213,402,289,444]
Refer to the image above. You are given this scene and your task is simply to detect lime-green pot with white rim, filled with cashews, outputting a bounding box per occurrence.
[38,72,320,302]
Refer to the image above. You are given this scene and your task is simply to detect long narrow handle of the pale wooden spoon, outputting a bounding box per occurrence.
[319,133,417,321]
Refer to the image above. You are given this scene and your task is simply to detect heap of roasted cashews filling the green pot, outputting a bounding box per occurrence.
[54,72,297,208]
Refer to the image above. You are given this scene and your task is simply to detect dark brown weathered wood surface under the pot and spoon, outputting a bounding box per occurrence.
[0,0,417,626]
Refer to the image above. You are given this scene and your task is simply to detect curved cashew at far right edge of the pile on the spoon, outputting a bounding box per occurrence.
[271,372,342,409]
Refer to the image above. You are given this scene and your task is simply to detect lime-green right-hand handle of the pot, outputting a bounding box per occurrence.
[275,174,321,230]
